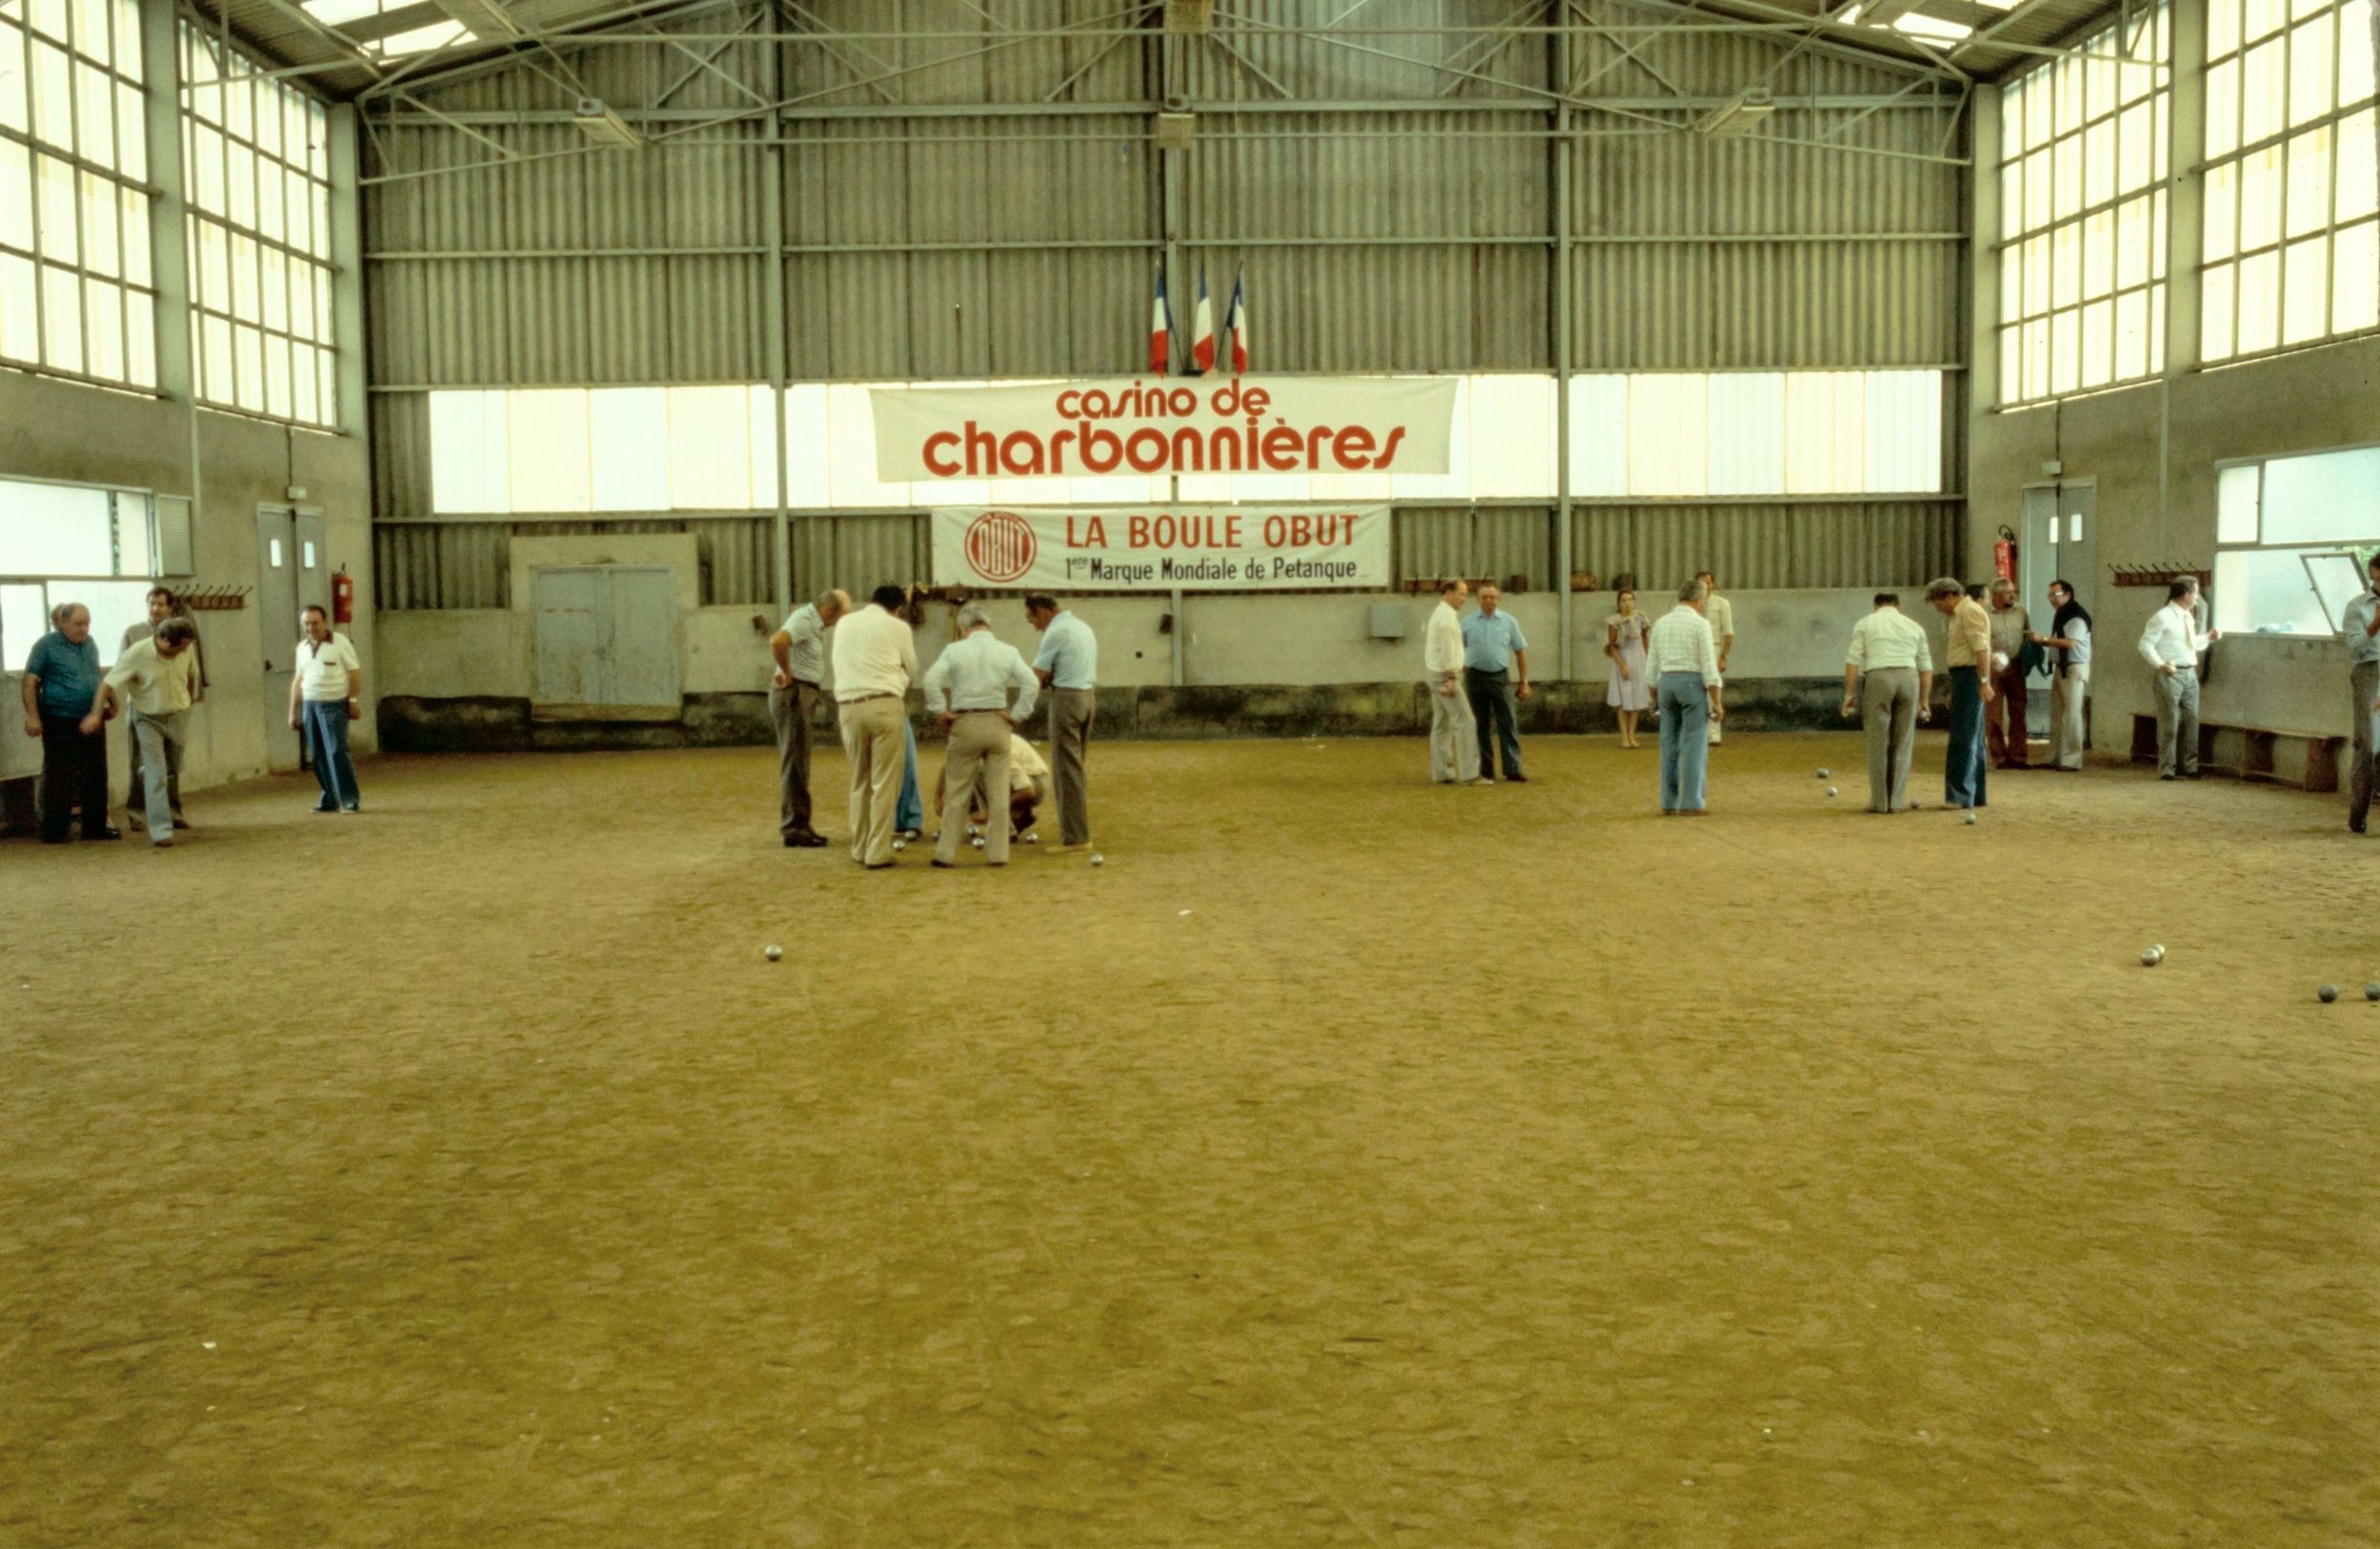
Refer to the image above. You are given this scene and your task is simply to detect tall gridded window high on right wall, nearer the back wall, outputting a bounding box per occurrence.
[1999,5,2173,405]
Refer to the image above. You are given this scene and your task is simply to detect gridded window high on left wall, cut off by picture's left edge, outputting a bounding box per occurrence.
[0,0,157,387]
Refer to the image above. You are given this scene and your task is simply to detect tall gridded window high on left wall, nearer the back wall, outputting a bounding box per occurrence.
[181,24,338,426]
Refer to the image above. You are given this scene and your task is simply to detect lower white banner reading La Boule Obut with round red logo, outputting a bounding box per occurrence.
[933,505,1388,592]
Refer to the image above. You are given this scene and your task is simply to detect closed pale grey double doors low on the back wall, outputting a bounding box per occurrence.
[531,564,679,714]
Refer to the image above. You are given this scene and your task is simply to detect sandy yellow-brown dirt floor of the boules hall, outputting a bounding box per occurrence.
[0,735,2380,1549]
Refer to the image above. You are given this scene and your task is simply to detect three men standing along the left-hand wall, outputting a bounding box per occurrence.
[24,586,365,849]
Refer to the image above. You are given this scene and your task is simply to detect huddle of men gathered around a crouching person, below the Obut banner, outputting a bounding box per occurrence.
[769,586,1100,871]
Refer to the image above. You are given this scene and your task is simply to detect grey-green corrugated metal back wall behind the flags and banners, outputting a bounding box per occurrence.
[365,0,1966,606]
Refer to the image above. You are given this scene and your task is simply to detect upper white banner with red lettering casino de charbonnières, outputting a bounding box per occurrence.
[869,376,1455,486]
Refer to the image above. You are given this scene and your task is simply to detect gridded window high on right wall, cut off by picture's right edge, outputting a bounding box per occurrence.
[2199,0,2380,362]
